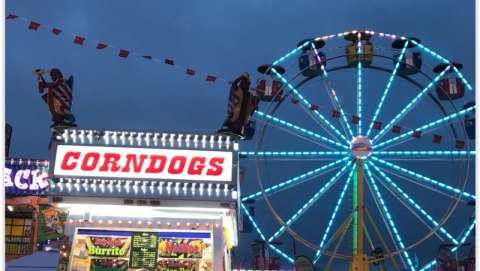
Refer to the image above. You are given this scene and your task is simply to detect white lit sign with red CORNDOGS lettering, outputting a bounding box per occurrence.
[51,130,236,183]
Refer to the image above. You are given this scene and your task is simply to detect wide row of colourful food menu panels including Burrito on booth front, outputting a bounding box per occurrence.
[68,228,213,271]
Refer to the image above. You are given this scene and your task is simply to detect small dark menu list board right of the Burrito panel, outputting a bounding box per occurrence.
[130,232,157,268]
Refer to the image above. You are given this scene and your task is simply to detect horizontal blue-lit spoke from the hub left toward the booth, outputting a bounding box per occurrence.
[239,151,348,161]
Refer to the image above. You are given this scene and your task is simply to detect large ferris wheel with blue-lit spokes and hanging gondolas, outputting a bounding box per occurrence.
[240,30,475,270]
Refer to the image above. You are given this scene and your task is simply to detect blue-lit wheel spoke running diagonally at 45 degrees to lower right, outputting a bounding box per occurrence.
[368,161,458,245]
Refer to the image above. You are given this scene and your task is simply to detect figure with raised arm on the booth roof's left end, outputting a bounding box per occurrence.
[33,68,77,129]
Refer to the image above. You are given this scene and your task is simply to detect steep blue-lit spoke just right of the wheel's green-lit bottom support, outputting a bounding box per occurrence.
[365,164,415,271]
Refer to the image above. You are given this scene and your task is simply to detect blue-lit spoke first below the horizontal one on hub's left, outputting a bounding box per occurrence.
[242,157,350,201]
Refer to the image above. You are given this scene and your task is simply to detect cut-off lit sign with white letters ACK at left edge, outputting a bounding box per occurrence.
[3,164,50,193]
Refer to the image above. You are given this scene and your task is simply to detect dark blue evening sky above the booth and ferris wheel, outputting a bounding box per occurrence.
[6,0,475,270]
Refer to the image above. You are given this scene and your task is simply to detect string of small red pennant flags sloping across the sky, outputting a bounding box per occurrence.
[6,14,472,149]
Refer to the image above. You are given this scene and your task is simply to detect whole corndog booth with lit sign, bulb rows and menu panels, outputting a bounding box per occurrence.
[8,129,239,271]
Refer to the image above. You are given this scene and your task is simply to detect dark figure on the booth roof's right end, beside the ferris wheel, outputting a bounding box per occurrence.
[218,72,252,137]
